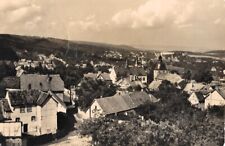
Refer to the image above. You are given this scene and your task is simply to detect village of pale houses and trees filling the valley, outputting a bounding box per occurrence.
[0,48,225,146]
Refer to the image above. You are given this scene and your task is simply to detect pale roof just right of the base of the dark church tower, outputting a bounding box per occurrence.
[156,73,182,84]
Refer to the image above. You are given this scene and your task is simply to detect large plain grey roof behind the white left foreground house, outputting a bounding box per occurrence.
[20,74,64,92]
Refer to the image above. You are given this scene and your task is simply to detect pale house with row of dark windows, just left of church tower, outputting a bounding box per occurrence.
[129,67,148,84]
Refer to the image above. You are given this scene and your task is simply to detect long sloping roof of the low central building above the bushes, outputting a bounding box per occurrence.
[93,92,155,115]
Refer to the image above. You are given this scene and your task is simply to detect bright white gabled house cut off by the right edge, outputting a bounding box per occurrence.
[205,87,225,109]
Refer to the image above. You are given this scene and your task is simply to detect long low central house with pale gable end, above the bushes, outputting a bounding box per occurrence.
[86,92,158,118]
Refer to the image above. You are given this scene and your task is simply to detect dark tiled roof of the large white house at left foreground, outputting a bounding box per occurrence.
[8,90,65,107]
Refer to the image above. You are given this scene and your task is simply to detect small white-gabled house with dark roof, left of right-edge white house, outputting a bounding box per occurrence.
[188,92,205,109]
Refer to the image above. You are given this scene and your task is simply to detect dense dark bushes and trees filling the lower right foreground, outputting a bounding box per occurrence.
[80,85,224,146]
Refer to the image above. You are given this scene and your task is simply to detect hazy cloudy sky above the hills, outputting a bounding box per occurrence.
[0,0,225,51]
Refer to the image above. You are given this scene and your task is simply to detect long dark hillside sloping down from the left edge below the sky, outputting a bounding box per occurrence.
[0,34,138,59]
